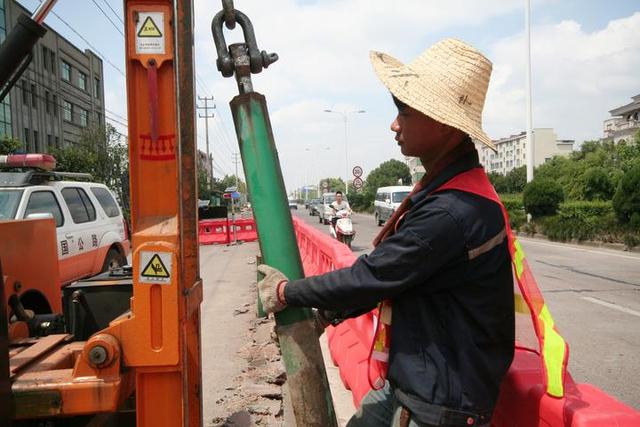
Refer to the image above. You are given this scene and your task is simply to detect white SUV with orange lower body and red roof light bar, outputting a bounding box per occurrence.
[0,155,130,285]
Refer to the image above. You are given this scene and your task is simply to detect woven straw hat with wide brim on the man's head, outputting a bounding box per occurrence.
[370,39,496,150]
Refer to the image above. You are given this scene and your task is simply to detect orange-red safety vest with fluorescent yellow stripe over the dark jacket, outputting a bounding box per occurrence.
[368,168,569,397]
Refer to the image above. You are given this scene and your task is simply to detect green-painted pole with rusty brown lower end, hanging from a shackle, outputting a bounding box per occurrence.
[230,91,337,427]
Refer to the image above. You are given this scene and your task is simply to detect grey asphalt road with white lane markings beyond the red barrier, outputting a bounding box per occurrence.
[293,208,640,409]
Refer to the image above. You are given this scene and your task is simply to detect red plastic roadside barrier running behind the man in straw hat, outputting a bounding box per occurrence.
[293,217,640,427]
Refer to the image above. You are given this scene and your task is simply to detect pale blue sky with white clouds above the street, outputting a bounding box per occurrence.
[21,0,640,193]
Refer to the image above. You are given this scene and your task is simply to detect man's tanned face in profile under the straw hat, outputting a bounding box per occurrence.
[391,106,460,160]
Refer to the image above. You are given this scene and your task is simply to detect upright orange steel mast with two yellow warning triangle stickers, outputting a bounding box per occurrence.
[103,0,202,427]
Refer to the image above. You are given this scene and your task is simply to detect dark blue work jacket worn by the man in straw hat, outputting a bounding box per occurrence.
[285,151,515,425]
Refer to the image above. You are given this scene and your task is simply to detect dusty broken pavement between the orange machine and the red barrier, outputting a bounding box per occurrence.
[200,243,354,427]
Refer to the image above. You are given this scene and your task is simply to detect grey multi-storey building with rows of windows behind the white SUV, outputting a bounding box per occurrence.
[0,0,105,152]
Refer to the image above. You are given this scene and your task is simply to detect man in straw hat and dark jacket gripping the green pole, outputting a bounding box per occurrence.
[259,39,515,427]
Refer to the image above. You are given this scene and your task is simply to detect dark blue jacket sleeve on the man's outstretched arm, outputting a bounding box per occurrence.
[282,209,465,310]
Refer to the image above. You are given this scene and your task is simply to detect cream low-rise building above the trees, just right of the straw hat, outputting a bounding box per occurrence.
[479,128,575,175]
